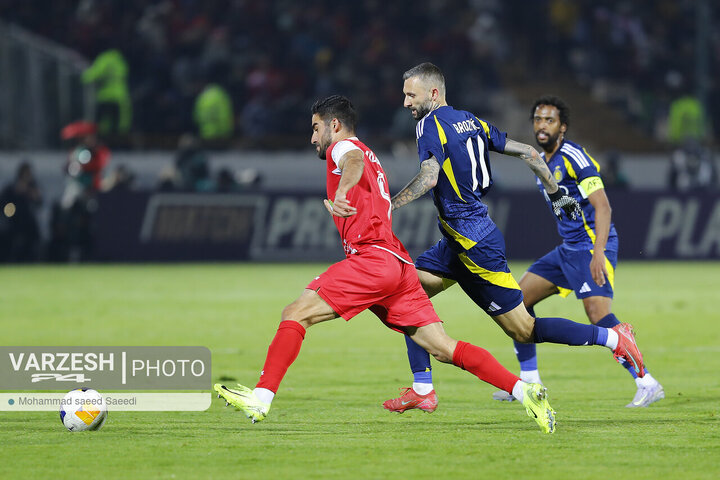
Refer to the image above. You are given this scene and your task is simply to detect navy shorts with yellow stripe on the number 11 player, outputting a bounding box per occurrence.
[415,228,522,316]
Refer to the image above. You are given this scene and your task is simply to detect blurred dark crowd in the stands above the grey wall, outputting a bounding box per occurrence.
[0,0,720,148]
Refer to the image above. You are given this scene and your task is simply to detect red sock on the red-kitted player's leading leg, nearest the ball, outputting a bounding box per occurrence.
[255,320,305,393]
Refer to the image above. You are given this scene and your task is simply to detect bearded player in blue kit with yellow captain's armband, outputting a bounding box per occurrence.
[493,96,665,408]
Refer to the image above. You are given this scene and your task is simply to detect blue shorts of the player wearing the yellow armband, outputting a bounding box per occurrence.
[528,245,617,299]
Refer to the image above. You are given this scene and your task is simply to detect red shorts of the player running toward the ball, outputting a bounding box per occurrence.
[307,247,441,333]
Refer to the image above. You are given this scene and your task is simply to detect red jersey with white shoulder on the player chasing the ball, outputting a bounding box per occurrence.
[326,137,412,263]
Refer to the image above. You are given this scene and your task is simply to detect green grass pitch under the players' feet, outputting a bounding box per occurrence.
[0,262,720,480]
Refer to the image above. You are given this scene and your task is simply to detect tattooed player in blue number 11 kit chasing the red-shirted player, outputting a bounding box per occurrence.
[383,63,644,412]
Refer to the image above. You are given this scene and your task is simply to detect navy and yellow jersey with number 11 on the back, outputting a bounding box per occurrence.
[416,106,506,249]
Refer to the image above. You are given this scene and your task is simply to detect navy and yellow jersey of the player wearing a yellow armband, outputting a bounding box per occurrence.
[536,140,617,250]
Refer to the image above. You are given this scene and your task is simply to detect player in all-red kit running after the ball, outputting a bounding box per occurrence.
[214,95,555,433]
